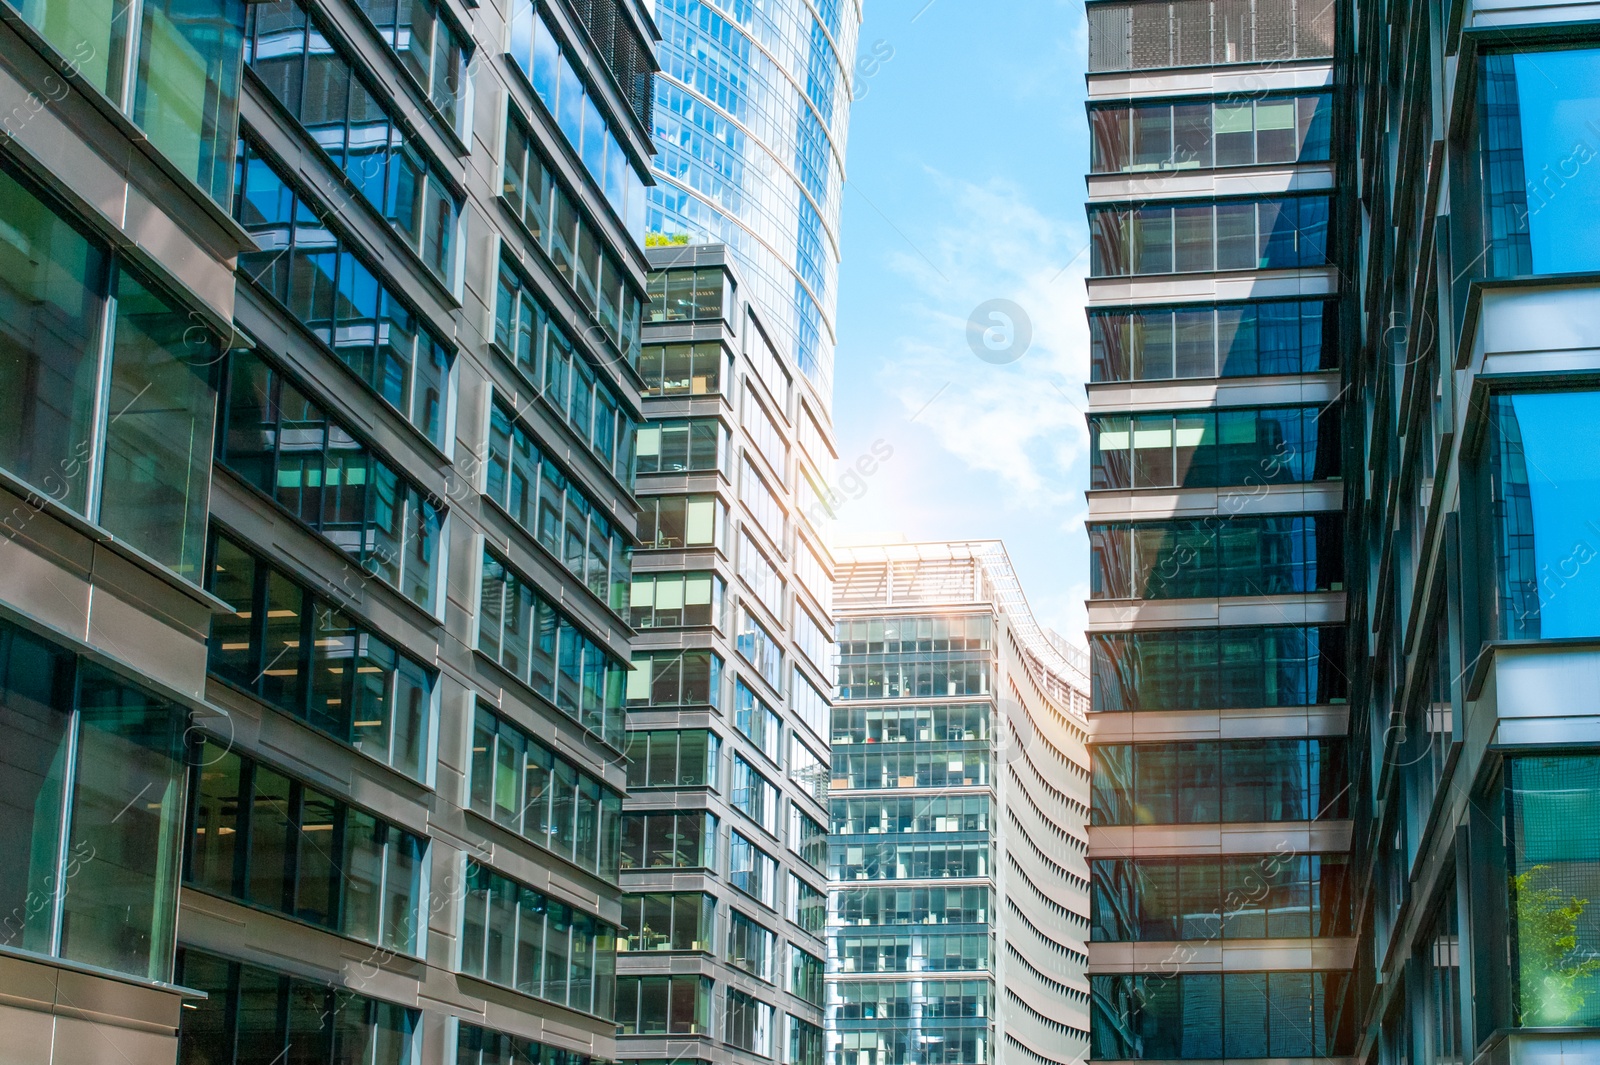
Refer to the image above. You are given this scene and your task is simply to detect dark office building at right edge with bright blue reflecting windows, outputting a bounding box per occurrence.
[1338,2,1600,1065]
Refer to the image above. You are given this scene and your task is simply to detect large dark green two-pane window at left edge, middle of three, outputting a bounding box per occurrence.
[0,161,219,580]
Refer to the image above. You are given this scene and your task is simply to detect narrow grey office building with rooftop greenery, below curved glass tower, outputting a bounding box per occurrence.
[618,245,834,1065]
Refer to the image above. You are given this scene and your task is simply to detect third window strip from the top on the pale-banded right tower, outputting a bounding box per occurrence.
[1090,299,1339,381]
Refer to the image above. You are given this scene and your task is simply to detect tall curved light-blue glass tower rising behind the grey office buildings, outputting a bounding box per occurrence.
[648,0,861,388]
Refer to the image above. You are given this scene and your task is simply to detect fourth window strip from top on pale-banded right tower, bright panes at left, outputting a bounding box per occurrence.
[1090,406,1341,491]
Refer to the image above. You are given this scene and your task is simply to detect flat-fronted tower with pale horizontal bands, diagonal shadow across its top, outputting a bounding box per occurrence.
[1088,0,1356,1062]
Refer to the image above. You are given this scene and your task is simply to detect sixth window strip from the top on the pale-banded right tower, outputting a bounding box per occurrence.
[1090,625,1349,712]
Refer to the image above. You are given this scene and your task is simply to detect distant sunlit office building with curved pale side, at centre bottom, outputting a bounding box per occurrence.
[827,540,1090,1065]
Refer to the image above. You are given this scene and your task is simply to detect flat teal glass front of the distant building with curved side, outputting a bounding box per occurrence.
[827,614,998,1065]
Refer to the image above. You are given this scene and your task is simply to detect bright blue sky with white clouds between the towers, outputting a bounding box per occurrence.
[834,0,1088,644]
